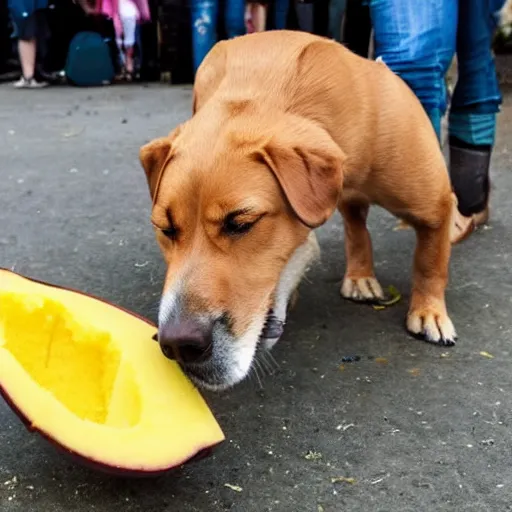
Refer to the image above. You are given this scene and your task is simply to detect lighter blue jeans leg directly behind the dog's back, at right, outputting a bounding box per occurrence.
[370,0,458,140]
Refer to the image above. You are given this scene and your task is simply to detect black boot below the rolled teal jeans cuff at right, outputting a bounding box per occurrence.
[450,136,492,224]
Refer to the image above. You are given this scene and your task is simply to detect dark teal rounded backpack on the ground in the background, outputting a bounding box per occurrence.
[65,31,115,86]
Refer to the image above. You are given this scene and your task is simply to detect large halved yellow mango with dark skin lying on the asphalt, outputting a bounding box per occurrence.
[0,269,224,475]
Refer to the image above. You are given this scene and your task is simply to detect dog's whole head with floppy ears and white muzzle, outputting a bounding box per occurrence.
[140,111,344,389]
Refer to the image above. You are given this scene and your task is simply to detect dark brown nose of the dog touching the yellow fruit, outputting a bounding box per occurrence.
[158,320,212,363]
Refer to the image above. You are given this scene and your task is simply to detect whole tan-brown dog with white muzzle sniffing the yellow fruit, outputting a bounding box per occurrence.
[140,31,468,389]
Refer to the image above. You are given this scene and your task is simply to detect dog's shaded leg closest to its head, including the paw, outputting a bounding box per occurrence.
[339,200,384,302]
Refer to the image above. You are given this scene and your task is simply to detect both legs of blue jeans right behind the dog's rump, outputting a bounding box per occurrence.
[369,0,505,145]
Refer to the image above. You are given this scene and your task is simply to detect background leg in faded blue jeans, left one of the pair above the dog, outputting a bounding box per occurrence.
[190,0,218,74]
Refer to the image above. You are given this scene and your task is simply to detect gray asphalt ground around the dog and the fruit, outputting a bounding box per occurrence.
[0,82,512,512]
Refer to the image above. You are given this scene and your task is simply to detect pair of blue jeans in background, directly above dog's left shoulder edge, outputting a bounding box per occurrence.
[190,0,245,73]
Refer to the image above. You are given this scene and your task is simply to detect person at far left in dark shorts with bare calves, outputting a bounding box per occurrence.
[8,0,49,89]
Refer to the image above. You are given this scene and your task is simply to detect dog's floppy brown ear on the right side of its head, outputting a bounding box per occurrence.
[258,116,346,228]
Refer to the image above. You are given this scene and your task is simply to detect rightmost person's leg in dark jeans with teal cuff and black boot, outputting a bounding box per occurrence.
[449,0,504,224]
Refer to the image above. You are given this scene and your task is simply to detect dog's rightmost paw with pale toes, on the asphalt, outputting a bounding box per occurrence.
[407,308,457,346]
